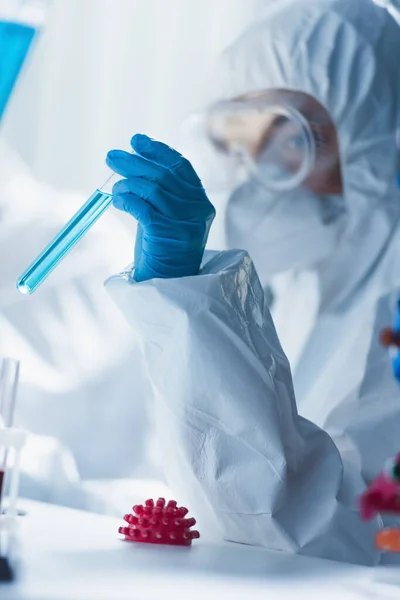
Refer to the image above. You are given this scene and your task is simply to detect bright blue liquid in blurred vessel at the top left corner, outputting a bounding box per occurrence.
[0,21,36,119]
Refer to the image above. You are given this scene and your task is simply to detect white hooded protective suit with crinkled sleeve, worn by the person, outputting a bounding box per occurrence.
[107,0,400,565]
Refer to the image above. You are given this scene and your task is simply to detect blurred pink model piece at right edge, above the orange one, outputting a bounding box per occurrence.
[360,454,400,521]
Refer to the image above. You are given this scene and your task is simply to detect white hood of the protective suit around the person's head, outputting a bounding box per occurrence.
[208,0,400,311]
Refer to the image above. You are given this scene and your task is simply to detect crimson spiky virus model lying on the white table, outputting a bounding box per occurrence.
[118,498,200,546]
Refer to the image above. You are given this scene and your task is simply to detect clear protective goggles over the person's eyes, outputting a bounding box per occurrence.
[205,92,334,191]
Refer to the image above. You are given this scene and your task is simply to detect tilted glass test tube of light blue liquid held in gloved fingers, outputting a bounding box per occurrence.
[17,173,121,294]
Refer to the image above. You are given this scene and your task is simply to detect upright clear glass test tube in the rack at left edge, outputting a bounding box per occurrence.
[0,358,19,514]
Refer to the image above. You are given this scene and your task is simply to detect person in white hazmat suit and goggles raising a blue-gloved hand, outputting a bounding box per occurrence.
[106,0,400,565]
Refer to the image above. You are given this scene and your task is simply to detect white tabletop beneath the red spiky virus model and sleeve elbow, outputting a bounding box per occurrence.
[0,502,400,600]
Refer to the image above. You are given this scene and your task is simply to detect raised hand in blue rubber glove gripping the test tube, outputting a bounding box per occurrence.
[107,134,215,281]
